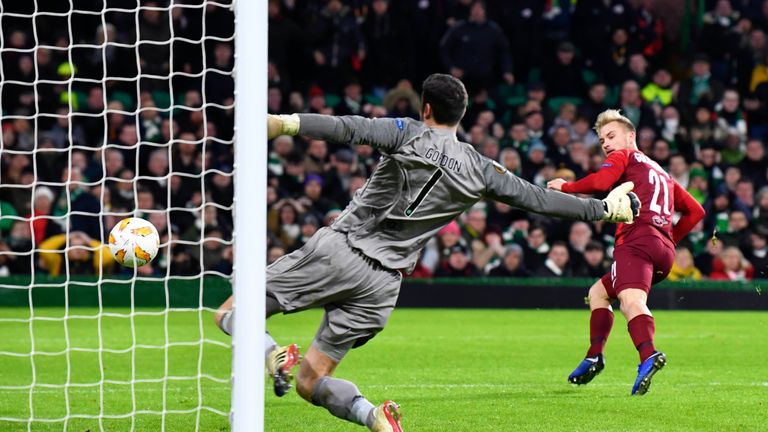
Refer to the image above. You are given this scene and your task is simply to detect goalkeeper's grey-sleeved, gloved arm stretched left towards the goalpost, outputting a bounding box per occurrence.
[267,114,412,153]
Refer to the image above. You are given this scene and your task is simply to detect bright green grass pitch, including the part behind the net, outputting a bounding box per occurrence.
[0,309,768,432]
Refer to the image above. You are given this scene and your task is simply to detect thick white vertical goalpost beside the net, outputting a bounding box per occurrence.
[232,0,267,432]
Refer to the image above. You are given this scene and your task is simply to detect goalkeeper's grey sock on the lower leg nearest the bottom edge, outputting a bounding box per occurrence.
[312,376,374,426]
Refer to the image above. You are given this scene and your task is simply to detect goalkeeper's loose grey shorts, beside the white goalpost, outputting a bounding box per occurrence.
[267,227,402,361]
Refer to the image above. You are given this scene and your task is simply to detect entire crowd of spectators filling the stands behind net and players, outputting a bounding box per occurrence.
[0,0,768,280]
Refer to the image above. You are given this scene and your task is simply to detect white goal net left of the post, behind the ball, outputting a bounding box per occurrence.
[0,0,246,431]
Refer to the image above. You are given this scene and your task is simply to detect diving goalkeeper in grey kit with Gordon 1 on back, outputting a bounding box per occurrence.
[216,74,640,431]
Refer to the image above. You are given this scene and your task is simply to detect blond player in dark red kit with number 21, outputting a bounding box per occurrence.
[547,110,704,395]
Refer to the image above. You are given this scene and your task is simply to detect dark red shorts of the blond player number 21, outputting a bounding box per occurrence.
[600,236,675,298]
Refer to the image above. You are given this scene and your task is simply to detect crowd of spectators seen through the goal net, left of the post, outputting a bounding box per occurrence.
[0,0,234,276]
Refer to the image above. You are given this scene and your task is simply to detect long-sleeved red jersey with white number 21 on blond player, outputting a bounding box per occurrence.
[562,150,704,246]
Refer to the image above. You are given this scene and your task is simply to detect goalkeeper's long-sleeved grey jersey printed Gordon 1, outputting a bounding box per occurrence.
[299,114,605,272]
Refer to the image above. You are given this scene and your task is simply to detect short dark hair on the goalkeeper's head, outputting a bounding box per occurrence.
[421,74,469,126]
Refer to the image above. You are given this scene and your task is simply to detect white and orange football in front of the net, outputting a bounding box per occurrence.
[109,218,160,267]
